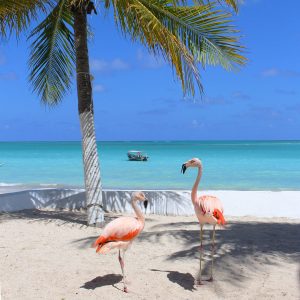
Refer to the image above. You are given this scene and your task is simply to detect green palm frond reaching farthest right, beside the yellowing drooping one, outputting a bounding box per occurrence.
[139,0,245,69]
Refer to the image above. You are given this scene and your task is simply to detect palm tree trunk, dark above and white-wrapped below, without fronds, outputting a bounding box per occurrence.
[74,7,104,226]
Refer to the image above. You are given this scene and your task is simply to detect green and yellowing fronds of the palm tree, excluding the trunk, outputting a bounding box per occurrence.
[0,0,245,105]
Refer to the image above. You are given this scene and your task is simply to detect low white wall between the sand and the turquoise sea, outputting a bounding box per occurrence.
[0,188,300,218]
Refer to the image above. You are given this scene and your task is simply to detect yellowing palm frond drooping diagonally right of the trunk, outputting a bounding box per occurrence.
[114,0,203,94]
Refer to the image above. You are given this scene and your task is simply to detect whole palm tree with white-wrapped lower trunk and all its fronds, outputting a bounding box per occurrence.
[0,0,246,224]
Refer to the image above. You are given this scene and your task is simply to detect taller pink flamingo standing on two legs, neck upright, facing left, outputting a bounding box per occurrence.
[181,158,226,285]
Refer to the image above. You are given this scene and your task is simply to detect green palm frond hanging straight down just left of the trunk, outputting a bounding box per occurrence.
[29,0,75,105]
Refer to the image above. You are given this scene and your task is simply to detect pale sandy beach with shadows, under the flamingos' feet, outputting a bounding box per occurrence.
[0,210,300,300]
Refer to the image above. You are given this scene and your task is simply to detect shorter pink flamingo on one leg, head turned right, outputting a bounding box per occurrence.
[93,192,148,293]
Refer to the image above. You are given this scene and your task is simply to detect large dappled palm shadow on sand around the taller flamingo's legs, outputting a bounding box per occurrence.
[140,221,300,288]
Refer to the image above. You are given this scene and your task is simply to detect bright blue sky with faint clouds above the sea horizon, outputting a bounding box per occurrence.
[0,0,300,141]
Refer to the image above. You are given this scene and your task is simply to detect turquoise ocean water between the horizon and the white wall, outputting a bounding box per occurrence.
[0,141,300,190]
